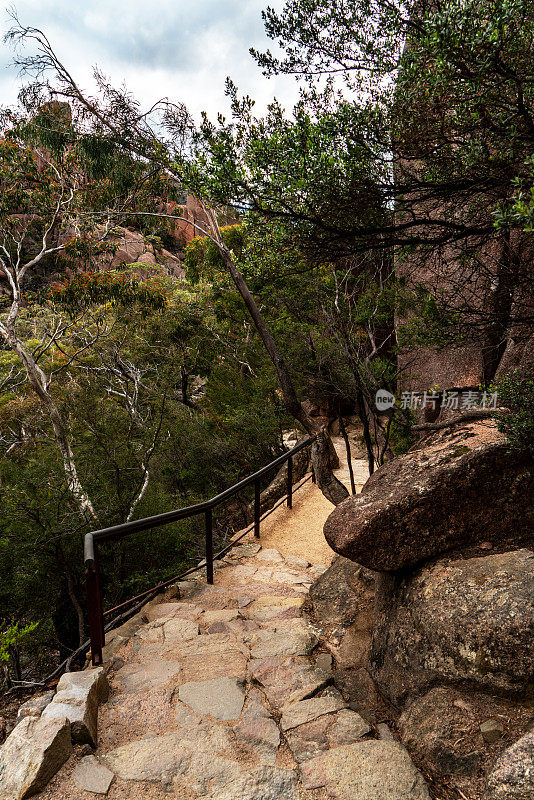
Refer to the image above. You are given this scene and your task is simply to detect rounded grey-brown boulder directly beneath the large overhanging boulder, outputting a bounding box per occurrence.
[371,549,534,705]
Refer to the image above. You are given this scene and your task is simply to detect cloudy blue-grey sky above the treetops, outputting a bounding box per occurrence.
[0,0,297,119]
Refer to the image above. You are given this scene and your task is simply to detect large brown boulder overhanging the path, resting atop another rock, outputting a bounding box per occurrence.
[324,422,534,571]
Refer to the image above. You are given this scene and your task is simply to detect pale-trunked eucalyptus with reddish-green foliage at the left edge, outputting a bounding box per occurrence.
[0,97,180,523]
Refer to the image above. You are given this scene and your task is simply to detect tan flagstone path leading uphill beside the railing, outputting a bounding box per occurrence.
[36,444,428,800]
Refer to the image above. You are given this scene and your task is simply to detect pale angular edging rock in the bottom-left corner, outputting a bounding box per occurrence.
[0,717,72,800]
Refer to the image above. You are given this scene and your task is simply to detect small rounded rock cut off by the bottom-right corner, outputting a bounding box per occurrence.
[484,731,534,800]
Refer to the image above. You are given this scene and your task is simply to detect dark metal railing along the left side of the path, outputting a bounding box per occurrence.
[84,437,315,666]
